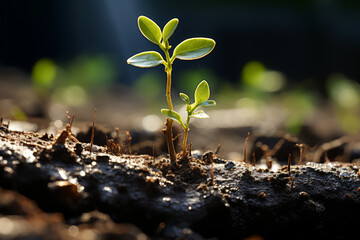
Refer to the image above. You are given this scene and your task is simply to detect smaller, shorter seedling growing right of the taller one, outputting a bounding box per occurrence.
[161,80,216,157]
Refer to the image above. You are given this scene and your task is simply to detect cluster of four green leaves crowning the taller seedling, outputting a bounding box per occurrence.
[127,16,215,68]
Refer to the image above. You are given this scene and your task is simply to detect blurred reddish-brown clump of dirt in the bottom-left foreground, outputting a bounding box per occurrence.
[0,188,148,240]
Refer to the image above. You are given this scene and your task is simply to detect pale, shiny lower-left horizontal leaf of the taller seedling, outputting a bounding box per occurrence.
[127,51,164,68]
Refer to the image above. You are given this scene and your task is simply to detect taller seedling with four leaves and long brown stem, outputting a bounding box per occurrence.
[127,16,215,165]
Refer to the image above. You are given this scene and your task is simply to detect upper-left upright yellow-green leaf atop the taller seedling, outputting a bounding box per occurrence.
[138,16,162,45]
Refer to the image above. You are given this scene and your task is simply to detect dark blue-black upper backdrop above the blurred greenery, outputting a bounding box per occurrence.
[0,0,360,87]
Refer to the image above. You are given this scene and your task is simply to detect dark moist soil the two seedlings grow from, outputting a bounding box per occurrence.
[0,124,360,240]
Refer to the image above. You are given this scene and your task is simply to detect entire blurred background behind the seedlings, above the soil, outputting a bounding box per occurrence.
[0,0,360,158]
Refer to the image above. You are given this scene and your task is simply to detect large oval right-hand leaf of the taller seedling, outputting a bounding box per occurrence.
[173,38,215,60]
